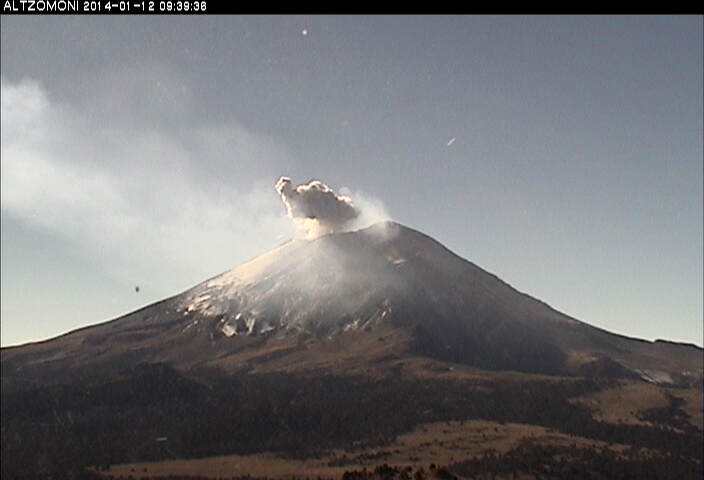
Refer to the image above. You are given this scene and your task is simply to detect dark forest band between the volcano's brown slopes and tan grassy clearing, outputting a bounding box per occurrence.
[0,365,702,478]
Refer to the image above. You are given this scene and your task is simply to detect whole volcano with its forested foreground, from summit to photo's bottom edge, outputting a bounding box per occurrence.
[0,222,702,480]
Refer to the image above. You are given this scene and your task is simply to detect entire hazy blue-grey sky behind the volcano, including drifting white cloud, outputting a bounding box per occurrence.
[0,16,703,345]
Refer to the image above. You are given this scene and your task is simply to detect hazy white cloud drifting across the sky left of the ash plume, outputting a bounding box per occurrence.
[1,78,292,293]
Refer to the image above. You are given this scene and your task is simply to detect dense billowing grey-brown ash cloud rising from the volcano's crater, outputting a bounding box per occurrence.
[274,177,360,238]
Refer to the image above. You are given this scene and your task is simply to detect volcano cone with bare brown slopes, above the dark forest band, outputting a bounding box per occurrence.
[2,222,702,391]
